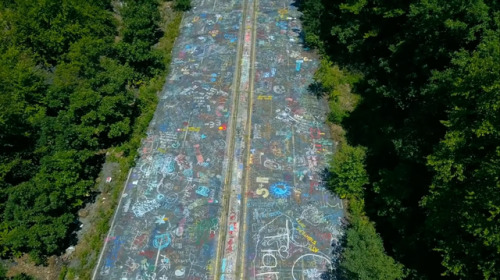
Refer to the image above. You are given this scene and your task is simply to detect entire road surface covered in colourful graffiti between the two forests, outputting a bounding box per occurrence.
[93,0,343,280]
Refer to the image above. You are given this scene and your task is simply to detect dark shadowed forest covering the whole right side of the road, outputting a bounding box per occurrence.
[299,0,500,279]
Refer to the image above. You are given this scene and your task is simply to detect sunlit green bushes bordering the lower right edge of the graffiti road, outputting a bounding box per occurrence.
[328,144,405,280]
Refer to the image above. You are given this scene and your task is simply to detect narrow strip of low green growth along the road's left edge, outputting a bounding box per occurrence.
[59,11,182,280]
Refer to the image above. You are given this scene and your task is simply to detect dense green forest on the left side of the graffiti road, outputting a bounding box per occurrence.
[0,0,189,272]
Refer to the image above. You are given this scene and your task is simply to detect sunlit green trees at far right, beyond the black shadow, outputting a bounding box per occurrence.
[423,20,500,279]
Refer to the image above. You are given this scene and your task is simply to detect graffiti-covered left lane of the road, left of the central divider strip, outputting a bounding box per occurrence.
[95,0,242,280]
